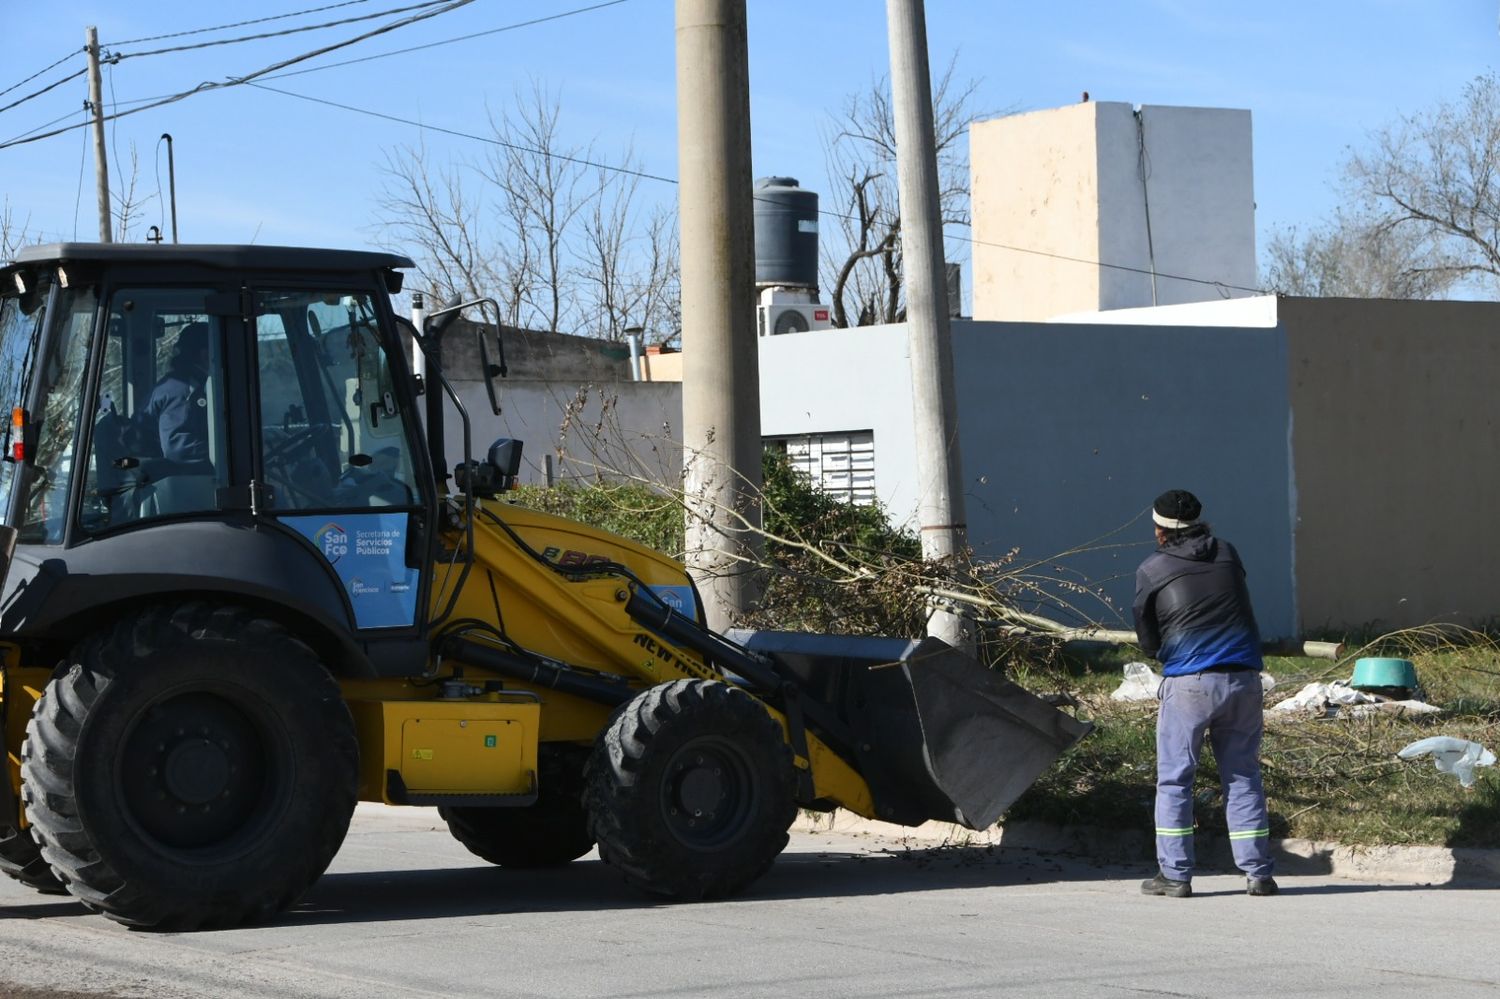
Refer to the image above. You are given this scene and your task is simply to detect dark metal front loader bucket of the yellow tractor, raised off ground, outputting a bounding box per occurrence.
[731,632,1094,830]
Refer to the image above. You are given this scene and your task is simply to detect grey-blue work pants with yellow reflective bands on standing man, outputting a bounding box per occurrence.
[1157,669,1272,881]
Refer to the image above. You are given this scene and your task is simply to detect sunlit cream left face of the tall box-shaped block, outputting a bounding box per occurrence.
[969,104,1100,321]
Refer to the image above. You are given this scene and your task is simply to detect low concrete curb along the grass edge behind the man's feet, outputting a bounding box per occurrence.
[792,810,1500,888]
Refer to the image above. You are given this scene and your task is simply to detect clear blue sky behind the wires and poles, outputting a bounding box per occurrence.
[0,0,1500,280]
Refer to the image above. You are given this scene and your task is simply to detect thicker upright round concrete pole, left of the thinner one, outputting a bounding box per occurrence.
[677,0,761,629]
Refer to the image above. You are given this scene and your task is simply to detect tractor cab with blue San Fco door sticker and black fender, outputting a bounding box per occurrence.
[0,245,441,675]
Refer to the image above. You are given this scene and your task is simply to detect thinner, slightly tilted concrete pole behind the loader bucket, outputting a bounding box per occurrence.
[885,0,972,648]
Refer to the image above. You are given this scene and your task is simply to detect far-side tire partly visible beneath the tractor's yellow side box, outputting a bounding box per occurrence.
[438,747,594,870]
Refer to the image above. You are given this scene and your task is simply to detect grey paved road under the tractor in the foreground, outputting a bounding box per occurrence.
[0,806,1500,999]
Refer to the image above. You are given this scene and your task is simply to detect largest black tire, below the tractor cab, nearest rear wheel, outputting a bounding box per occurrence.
[21,603,359,930]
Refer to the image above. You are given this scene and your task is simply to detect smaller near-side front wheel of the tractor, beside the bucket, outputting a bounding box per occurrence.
[585,680,797,900]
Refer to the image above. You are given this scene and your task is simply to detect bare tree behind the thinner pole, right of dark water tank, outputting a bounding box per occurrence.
[822,56,992,326]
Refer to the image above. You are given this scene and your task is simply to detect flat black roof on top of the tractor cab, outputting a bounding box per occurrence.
[10,243,414,272]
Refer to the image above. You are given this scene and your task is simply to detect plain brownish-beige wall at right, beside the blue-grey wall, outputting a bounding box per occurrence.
[1280,299,1500,630]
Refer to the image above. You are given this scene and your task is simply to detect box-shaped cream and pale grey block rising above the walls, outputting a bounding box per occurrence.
[969,102,1256,321]
